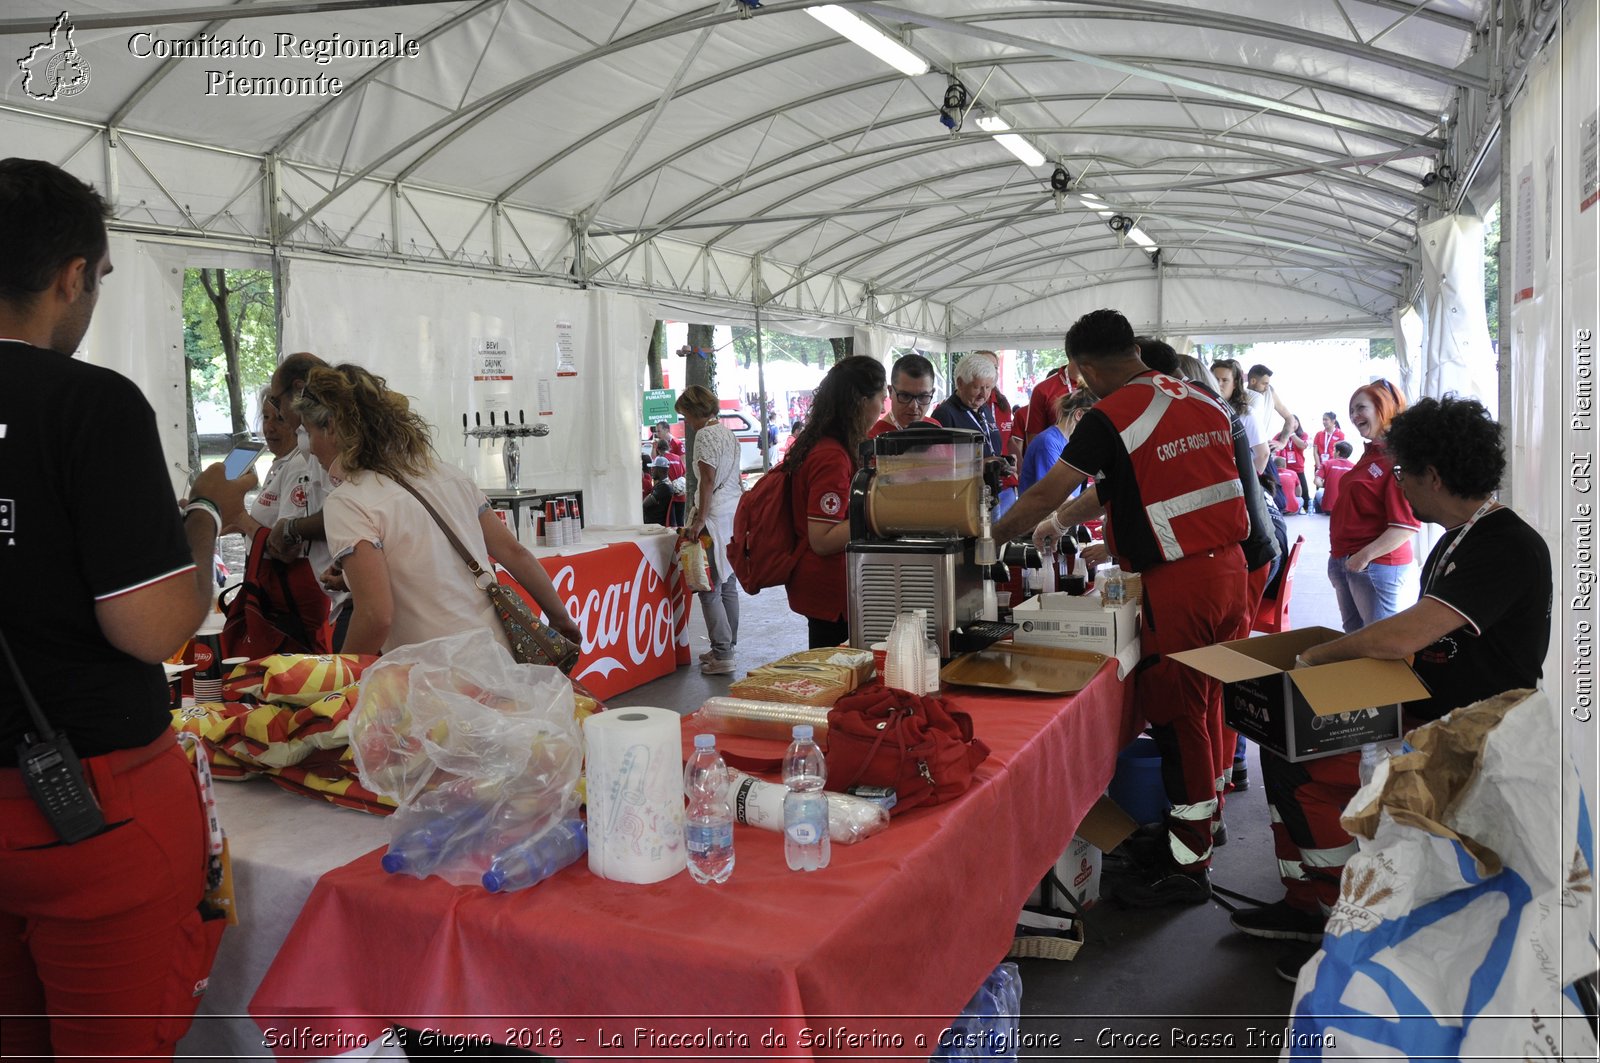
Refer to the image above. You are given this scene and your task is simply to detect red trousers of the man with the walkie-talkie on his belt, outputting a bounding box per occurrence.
[0,733,222,1063]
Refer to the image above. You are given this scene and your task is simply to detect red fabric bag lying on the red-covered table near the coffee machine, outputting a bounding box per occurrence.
[827,684,989,815]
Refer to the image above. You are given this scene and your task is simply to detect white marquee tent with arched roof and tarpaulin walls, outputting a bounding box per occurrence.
[0,0,1600,765]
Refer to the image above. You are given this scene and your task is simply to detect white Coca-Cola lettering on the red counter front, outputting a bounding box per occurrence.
[550,554,674,679]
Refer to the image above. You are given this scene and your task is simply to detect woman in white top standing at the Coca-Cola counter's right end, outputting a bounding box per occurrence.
[677,384,744,676]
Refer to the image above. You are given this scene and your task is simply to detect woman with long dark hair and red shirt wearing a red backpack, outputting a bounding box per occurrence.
[784,354,883,648]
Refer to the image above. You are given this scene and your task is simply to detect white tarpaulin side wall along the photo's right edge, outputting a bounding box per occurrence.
[1501,0,1600,845]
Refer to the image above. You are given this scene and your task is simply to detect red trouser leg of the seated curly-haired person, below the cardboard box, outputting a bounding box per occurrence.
[1261,749,1362,914]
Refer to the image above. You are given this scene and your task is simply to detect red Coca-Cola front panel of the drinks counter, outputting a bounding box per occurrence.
[499,536,690,700]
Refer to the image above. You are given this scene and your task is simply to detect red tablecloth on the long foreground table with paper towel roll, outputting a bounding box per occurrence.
[250,663,1138,1060]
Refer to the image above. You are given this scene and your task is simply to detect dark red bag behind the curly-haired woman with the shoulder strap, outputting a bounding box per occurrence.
[222,528,333,660]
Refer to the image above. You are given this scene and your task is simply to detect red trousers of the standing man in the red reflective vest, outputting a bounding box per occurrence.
[1134,546,1246,871]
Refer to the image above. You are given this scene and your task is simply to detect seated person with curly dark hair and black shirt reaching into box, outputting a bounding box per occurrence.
[1232,397,1552,981]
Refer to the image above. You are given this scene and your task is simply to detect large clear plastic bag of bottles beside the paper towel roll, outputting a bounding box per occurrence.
[350,632,582,885]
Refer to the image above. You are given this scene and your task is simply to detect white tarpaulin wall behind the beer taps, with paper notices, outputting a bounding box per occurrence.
[280,258,653,523]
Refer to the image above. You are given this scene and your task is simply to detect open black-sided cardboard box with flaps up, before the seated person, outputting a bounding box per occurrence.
[1170,628,1429,760]
